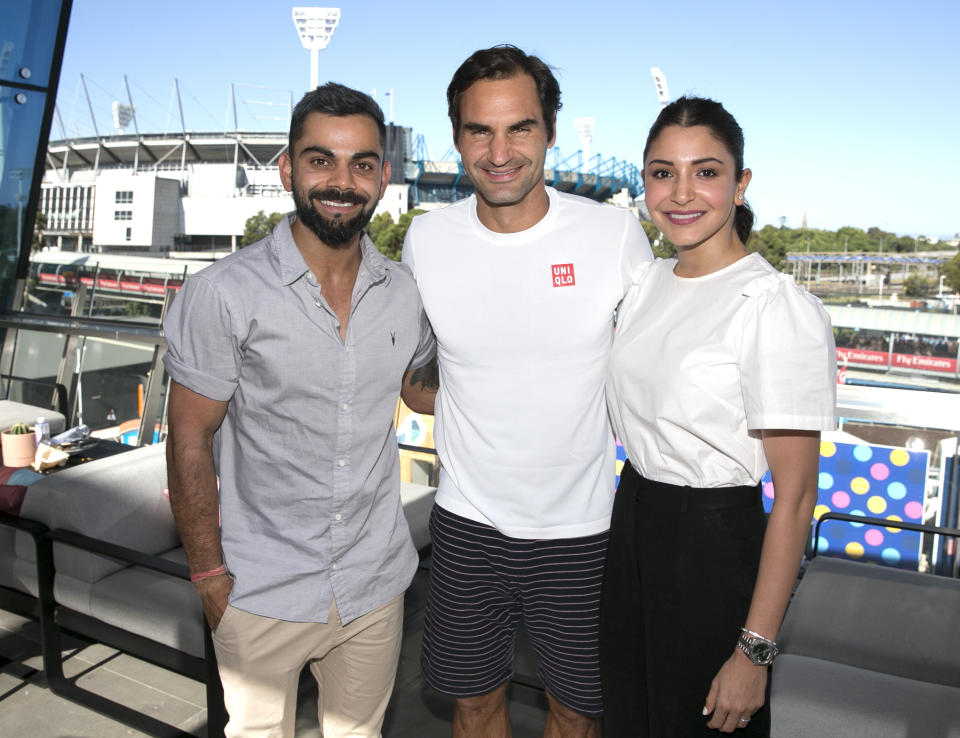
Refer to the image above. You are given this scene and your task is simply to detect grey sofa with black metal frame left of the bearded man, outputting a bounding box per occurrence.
[0,444,435,736]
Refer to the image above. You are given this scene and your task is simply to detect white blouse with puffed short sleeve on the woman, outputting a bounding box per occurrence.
[607,254,836,487]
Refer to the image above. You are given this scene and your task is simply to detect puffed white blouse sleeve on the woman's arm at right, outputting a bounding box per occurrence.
[740,274,837,431]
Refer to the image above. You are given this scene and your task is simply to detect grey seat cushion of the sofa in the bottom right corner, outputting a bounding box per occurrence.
[770,654,960,738]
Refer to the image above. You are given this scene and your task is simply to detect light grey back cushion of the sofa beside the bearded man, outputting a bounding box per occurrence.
[16,444,180,583]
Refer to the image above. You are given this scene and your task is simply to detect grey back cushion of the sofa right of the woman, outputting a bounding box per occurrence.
[777,556,960,687]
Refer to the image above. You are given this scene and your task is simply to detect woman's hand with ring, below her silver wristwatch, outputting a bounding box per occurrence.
[703,648,767,733]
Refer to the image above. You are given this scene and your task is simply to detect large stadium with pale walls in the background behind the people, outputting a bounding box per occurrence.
[39,131,642,254]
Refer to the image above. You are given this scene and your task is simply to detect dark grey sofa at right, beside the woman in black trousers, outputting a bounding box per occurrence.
[771,521,960,738]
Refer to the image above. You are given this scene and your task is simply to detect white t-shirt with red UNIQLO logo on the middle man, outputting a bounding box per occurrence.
[403,187,652,539]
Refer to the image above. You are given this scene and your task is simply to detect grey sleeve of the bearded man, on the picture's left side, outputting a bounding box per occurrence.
[163,273,243,401]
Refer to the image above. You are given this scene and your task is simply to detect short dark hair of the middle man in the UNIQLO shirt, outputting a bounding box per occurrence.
[447,44,563,141]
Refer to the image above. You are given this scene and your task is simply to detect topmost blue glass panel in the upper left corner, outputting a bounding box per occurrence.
[0,0,63,87]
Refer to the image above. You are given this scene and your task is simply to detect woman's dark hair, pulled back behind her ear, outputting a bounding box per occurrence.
[643,97,754,243]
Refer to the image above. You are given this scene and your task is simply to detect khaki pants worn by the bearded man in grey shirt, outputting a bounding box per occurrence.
[213,595,403,738]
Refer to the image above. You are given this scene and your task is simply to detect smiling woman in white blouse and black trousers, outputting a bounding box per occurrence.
[600,98,836,738]
